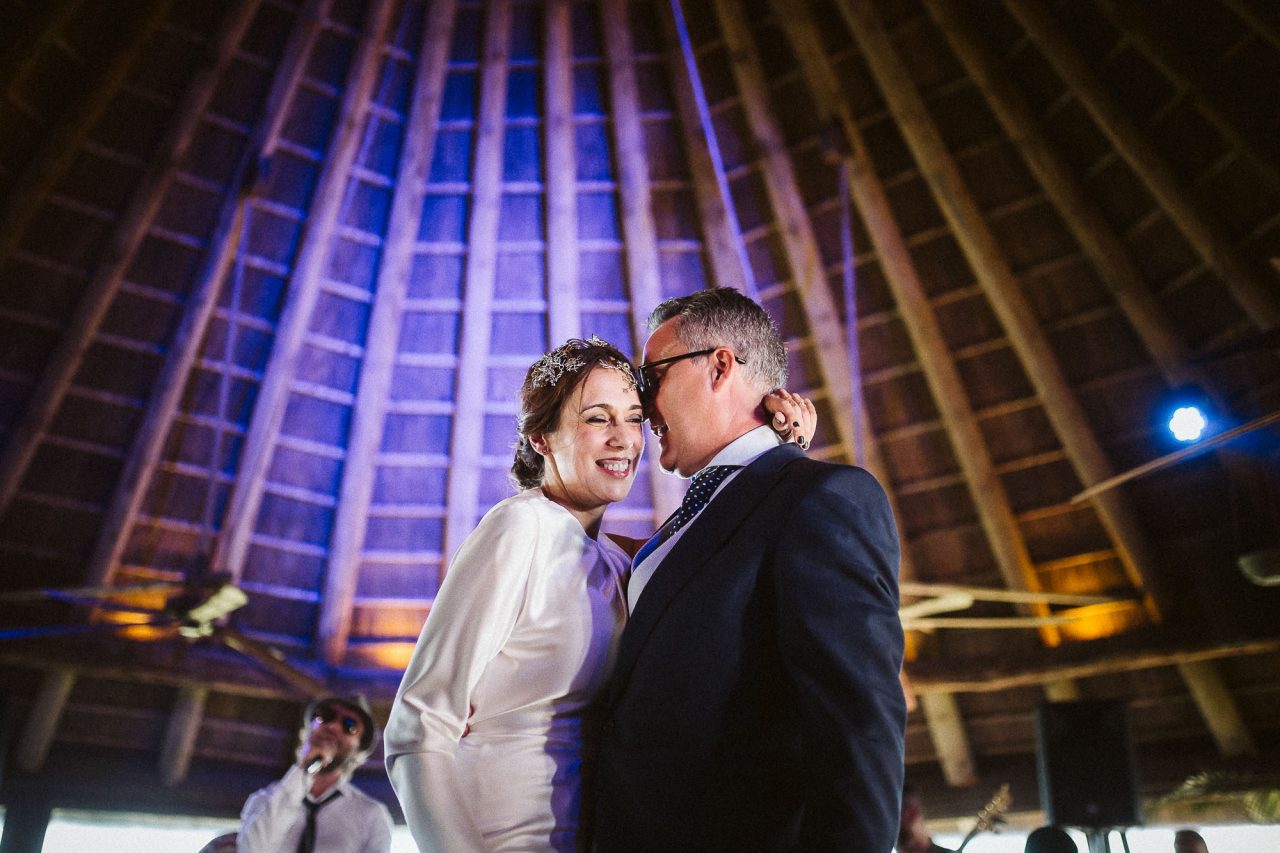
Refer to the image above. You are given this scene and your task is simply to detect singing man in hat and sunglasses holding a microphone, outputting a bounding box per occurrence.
[236,695,392,853]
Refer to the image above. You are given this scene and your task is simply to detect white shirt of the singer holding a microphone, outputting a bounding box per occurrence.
[236,765,392,853]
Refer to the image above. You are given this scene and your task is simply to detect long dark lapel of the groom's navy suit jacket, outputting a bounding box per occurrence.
[609,444,804,702]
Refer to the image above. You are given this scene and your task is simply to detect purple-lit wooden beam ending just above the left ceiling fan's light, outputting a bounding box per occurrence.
[212,0,394,578]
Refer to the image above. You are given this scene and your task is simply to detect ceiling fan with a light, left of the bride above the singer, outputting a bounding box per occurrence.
[0,573,328,697]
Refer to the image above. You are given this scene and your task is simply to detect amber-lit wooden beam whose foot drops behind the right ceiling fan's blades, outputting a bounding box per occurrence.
[773,0,1060,650]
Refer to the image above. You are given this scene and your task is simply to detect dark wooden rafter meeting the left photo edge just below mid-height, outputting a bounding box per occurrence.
[0,0,257,512]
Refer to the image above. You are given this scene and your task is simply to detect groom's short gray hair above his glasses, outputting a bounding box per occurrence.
[649,287,787,397]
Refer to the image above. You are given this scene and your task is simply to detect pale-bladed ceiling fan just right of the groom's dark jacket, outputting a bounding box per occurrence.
[899,580,1119,631]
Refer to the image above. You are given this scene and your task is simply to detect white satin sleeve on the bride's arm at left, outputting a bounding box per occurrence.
[383,494,539,853]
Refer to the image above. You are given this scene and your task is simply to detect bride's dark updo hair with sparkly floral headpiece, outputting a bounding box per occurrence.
[511,334,635,489]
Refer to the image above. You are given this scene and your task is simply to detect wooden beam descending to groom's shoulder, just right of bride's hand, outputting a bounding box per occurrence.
[714,0,860,460]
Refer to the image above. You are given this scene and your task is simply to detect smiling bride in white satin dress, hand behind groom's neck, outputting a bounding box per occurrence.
[383,337,815,853]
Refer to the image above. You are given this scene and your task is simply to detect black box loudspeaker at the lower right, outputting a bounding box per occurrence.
[1036,702,1142,829]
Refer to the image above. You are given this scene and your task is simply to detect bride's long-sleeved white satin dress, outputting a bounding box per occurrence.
[384,489,630,853]
